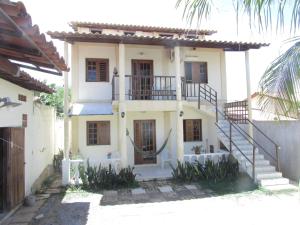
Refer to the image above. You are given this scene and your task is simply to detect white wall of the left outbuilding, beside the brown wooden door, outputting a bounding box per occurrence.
[0,79,56,195]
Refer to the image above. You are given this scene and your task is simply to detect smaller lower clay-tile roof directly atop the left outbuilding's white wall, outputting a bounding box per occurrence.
[0,71,54,94]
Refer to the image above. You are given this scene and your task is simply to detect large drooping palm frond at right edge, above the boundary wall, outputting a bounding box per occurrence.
[259,39,300,118]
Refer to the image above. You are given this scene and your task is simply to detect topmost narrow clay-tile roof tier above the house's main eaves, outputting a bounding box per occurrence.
[70,21,217,35]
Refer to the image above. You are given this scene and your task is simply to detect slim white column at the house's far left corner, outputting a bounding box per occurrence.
[62,42,70,185]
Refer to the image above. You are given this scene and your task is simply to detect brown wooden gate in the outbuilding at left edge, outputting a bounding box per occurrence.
[0,128,25,210]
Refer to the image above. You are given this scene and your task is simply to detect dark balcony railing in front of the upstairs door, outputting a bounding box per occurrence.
[112,75,176,100]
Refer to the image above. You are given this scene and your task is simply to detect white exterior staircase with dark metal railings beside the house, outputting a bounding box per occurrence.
[190,81,297,190]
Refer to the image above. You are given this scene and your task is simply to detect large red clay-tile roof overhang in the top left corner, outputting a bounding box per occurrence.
[0,1,68,74]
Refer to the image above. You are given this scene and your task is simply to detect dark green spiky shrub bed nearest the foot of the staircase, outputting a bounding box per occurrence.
[172,155,239,182]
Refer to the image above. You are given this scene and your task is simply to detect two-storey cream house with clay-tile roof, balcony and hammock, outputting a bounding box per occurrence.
[48,22,290,188]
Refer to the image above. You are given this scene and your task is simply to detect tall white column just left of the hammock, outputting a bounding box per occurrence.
[119,43,128,167]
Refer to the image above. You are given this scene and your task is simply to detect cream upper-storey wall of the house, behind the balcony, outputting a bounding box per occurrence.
[71,42,226,102]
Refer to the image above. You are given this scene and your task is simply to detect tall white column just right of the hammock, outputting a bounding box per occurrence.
[174,46,184,162]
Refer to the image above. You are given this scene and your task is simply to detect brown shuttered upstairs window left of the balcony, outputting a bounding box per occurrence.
[86,59,109,82]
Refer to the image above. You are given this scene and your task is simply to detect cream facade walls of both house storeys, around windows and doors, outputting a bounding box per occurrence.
[70,42,226,166]
